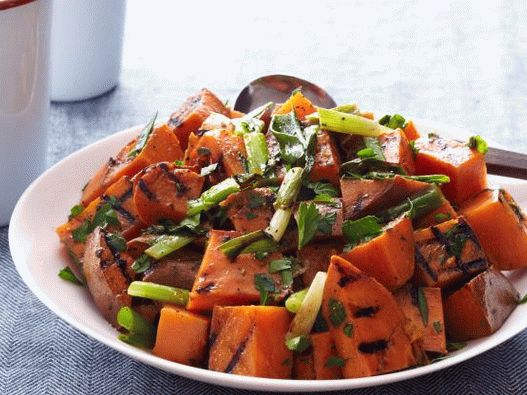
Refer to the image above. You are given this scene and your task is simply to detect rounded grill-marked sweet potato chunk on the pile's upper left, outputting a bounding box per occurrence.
[134,162,204,225]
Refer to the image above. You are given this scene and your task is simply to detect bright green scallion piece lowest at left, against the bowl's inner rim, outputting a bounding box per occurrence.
[117,306,156,349]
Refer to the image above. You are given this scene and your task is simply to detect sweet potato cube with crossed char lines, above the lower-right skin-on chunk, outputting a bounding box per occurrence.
[414,217,488,288]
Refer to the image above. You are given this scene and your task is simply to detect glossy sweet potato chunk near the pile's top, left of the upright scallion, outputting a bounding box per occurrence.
[185,129,247,177]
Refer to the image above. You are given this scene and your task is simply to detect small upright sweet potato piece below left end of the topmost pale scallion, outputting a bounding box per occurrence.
[309,130,340,187]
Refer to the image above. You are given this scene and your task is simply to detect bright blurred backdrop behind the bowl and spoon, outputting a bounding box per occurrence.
[49,0,527,164]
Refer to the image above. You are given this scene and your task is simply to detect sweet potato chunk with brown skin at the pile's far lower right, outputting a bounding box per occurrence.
[444,269,520,341]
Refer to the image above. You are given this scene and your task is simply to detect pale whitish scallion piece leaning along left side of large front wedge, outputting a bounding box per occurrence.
[285,272,327,340]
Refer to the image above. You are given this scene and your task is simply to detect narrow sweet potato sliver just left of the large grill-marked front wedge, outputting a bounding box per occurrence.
[311,332,342,380]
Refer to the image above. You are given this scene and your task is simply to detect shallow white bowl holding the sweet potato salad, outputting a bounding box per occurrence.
[9,122,527,392]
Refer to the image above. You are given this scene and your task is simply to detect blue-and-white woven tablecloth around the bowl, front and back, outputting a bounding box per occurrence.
[0,0,527,395]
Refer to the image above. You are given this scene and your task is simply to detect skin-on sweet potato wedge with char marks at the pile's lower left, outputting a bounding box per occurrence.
[82,227,133,327]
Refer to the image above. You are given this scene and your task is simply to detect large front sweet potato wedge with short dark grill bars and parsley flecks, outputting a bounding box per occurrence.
[322,256,416,378]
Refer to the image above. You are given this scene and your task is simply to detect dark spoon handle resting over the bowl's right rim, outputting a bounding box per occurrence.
[485,147,527,180]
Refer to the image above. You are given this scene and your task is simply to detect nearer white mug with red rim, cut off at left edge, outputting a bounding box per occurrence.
[0,0,51,226]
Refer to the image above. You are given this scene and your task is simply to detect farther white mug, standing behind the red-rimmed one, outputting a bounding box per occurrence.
[51,0,126,101]
